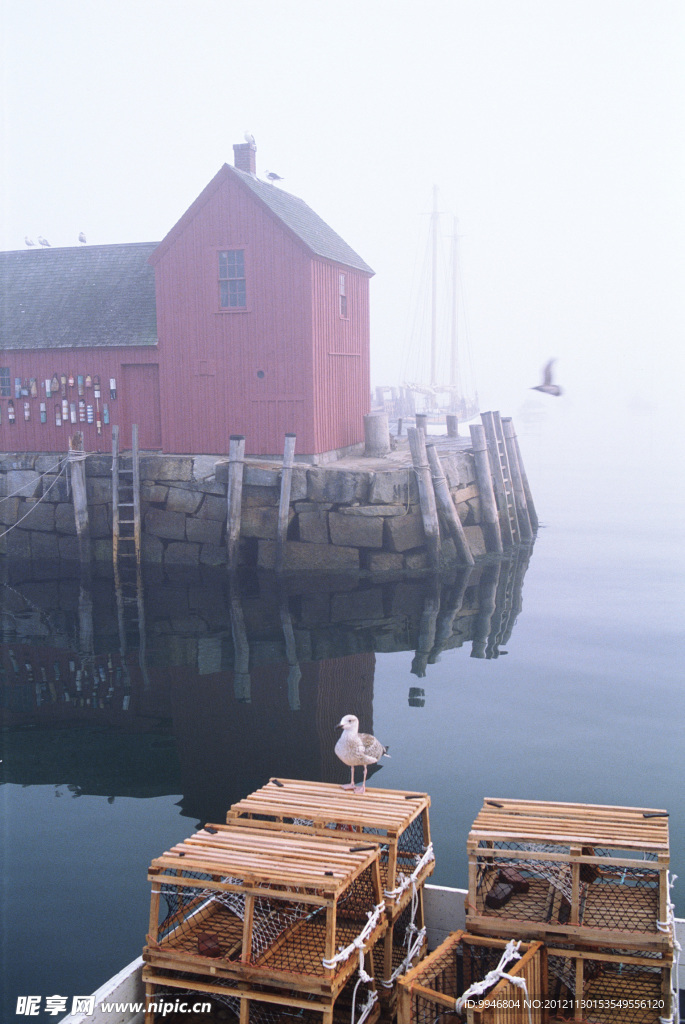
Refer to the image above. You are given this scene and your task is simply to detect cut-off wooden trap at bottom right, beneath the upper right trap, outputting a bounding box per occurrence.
[547,946,673,1024]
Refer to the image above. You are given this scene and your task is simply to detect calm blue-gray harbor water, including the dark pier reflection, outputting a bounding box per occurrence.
[0,399,685,1021]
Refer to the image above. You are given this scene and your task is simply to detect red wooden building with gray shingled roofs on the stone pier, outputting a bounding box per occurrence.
[0,143,373,456]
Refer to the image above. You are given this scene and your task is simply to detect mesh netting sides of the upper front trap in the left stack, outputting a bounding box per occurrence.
[152,865,376,977]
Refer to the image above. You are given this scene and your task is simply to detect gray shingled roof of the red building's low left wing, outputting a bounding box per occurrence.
[0,242,158,349]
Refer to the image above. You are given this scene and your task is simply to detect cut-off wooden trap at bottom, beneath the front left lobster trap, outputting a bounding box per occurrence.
[142,966,381,1024]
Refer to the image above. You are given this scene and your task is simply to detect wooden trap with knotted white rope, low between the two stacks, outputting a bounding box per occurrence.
[397,931,546,1024]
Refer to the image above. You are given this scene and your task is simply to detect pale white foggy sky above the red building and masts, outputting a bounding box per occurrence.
[0,0,685,416]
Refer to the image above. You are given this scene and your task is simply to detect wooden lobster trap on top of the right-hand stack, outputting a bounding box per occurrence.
[466,800,672,950]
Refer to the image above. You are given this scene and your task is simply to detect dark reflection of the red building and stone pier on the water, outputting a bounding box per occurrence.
[0,548,530,821]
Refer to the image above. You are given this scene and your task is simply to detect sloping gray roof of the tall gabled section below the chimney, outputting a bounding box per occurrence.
[225,164,374,273]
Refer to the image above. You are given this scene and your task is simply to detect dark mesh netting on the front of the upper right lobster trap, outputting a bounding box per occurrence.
[472,842,662,932]
